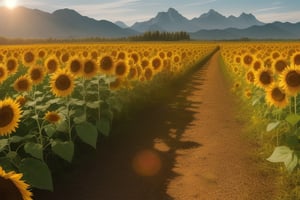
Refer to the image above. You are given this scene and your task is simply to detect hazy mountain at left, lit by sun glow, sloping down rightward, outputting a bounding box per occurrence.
[0,7,137,38]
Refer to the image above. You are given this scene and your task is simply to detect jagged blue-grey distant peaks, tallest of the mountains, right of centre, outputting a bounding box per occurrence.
[131,8,264,32]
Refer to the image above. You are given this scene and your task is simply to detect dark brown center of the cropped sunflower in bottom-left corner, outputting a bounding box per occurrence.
[0,177,23,200]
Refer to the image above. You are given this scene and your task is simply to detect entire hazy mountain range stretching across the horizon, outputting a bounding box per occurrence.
[0,7,300,40]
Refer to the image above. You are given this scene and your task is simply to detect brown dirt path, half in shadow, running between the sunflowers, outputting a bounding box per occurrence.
[34,53,274,200]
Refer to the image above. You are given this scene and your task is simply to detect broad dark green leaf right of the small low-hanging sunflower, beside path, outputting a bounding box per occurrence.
[76,122,98,149]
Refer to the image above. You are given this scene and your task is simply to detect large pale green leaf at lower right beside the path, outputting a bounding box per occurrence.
[267,146,298,172]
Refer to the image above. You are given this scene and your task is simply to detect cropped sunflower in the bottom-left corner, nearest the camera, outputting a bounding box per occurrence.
[0,167,32,200]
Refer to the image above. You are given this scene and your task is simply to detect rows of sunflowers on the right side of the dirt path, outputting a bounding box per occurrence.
[222,42,300,173]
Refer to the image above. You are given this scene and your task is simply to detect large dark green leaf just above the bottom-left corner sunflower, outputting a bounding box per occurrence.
[19,158,53,191]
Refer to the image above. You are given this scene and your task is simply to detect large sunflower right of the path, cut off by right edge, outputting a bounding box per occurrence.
[279,66,300,96]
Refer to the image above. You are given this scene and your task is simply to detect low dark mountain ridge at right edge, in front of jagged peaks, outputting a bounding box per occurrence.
[190,22,300,40]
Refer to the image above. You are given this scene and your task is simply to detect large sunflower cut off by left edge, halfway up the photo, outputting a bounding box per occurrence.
[0,98,21,136]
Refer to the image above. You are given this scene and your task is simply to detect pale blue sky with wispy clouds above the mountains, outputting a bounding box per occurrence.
[0,0,300,25]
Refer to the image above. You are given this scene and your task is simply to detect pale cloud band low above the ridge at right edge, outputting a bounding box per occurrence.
[256,11,300,22]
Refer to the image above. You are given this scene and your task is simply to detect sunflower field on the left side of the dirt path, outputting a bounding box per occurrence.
[0,43,218,195]
